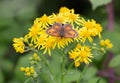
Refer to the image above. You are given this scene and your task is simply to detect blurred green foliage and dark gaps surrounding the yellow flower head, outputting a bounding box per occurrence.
[0,0,120,83]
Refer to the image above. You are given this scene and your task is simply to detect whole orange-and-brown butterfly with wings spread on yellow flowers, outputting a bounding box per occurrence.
[46,23,78,38]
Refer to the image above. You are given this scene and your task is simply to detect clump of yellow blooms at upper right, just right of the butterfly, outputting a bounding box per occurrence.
[79,19,102,43]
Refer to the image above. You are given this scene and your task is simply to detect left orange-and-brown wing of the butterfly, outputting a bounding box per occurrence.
[46,23,62,37]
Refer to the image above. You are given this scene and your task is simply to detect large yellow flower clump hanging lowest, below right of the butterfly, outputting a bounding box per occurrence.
[69,44,93,67]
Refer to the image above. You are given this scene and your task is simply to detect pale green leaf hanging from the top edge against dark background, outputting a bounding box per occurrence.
[90,0,111,10]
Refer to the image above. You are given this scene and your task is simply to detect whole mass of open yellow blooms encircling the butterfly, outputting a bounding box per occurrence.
[13,7,112,67]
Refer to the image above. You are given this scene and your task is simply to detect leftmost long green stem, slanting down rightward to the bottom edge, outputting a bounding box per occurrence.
[37,52,57,83]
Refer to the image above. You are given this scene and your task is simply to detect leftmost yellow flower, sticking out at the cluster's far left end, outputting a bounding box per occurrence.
[13,37,25,53]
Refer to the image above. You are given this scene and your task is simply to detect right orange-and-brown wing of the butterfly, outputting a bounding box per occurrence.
[63,24,78,38]
